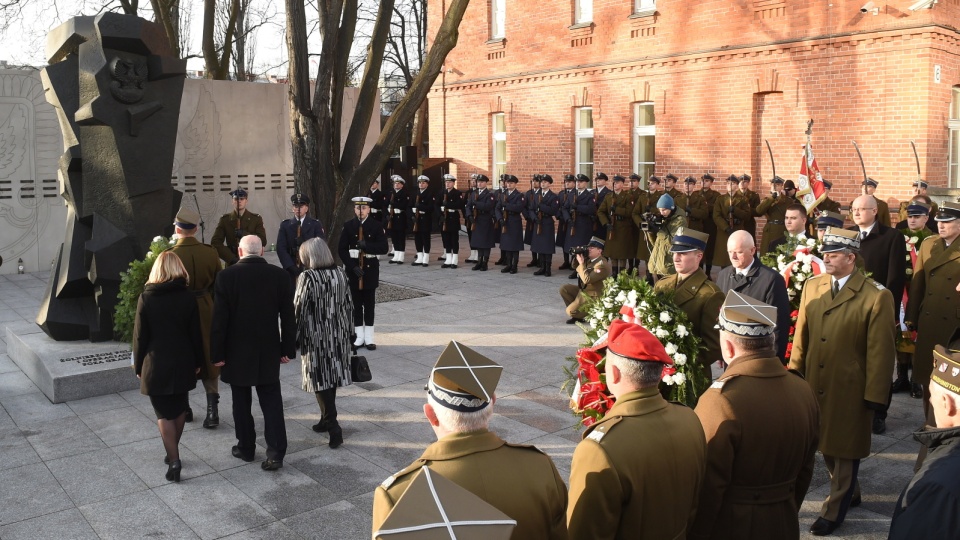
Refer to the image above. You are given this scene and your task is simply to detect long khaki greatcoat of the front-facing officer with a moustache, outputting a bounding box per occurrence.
[790,272,896,459]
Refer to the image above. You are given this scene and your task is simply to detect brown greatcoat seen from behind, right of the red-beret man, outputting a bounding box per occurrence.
[687,353,820,540]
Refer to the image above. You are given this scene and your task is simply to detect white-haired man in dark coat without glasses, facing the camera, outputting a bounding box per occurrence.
[717,231,793,365]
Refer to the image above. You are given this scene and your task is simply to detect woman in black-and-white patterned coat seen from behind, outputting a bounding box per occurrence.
[293,238,353,448]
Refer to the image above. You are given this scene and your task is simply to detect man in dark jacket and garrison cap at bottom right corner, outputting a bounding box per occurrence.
[889,345,960,540]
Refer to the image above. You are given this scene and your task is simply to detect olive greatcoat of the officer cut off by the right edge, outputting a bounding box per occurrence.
[906,236,960,392]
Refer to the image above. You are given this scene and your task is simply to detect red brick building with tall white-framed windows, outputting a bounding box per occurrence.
[428,0,960,208]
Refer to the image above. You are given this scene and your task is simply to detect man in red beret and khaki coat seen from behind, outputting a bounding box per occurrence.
[567,319,706,540]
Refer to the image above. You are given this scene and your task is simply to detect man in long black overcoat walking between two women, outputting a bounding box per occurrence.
[210,235,297,471]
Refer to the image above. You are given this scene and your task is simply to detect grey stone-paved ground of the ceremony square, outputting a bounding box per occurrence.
[0,240,921,540]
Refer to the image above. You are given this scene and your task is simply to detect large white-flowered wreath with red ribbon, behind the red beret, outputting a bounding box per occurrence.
[564,272,710,426]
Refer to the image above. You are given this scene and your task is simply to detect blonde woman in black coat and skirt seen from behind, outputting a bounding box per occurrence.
[133,251,204,482]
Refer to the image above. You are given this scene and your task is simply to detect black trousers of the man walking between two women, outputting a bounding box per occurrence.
[230,382,287,461]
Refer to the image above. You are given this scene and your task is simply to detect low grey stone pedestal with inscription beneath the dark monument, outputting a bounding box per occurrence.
[6,327,140,403]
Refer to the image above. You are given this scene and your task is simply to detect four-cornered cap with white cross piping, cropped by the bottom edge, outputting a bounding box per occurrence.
[373,465,517,540]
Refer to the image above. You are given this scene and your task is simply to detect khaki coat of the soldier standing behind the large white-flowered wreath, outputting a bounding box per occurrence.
[653,268,724,374]
